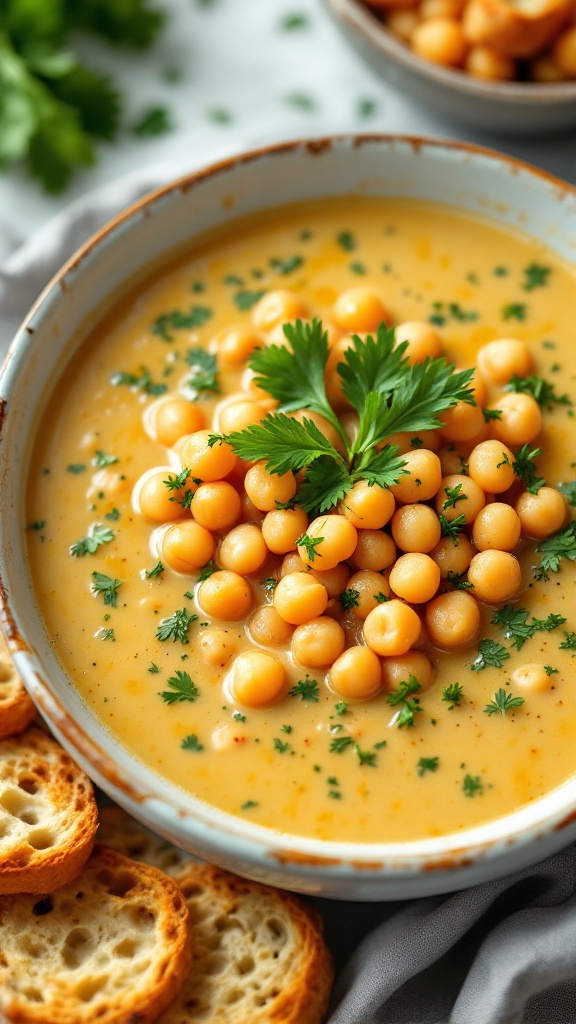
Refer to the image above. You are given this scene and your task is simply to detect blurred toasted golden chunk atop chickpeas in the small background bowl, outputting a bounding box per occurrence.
[462,0,572,57]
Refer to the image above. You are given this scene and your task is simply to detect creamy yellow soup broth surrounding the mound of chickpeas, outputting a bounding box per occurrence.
[27,199,576,843]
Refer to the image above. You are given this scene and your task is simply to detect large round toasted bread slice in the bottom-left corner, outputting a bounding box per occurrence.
[0,846,191,1024]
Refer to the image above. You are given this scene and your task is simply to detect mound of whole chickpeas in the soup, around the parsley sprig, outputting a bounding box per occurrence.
[134,288,567,708]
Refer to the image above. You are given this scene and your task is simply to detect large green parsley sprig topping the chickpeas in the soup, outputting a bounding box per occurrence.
[209,319,474,512]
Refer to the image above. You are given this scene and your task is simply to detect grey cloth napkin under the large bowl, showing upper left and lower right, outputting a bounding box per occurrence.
[0,165,576,1024]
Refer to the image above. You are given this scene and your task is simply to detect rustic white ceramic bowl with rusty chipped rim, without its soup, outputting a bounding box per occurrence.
[0,136,576,900]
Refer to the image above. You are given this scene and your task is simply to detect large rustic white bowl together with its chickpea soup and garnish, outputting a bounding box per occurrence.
[0,136,576,899]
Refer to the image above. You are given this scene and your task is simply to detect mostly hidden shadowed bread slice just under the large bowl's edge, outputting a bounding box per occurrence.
[96,806,192,876]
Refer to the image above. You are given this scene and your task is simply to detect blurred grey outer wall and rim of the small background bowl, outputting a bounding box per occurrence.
[325,0,576,136]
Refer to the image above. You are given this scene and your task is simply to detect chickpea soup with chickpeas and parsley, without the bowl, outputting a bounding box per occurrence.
[27,199,576,843]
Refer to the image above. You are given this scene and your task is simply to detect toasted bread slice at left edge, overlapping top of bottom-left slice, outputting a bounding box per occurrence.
[0,726,97,895]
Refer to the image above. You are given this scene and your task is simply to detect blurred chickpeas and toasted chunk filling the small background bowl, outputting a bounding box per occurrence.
[366,0,576,83]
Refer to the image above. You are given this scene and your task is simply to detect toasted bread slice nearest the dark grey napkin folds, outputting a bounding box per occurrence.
[159,862,333,1024]
